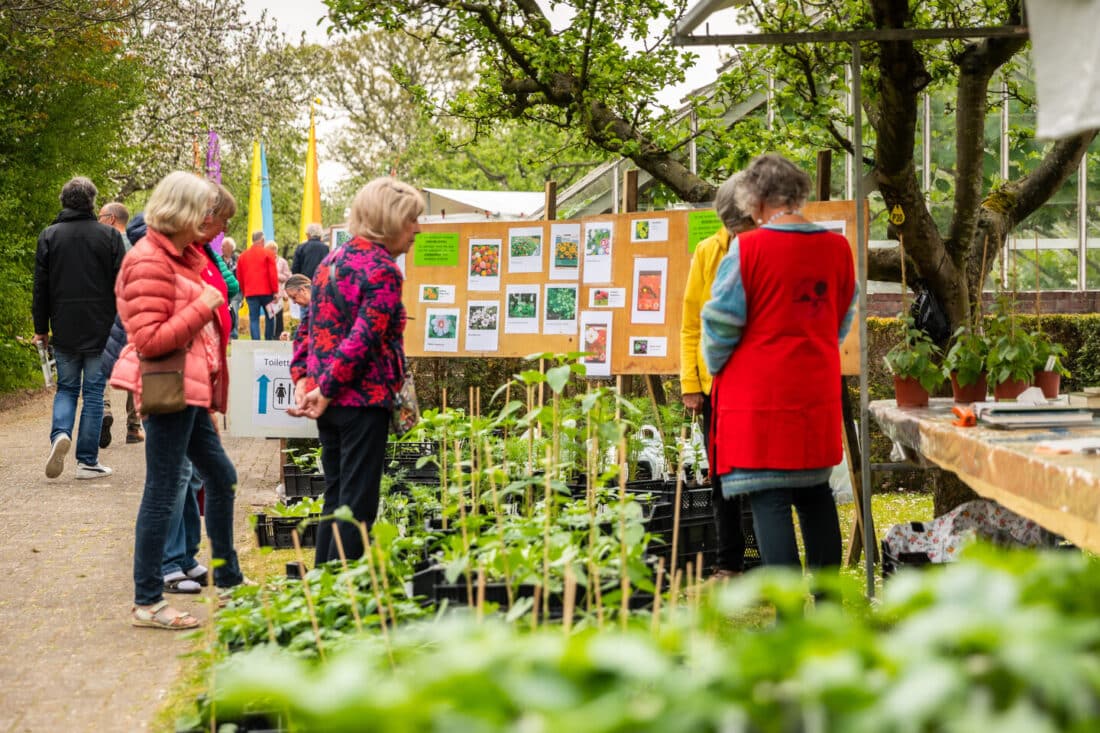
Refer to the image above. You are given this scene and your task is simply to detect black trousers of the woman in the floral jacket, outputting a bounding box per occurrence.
[315,406,389,565]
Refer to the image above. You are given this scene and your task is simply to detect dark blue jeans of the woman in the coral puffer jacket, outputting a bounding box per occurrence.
[134,407,244,605]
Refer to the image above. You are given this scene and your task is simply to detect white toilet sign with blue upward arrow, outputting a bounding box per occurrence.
[229,340,317,438]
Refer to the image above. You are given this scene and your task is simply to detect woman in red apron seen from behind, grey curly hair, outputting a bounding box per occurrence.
[702,154,856,568]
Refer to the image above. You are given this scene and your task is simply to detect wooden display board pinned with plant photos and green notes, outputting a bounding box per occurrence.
[404,201,859,374]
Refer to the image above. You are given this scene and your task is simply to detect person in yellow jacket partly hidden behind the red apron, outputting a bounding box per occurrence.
[680,174,755,577]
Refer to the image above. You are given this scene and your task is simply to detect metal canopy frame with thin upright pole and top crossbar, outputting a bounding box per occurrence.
[672,21,1029,598]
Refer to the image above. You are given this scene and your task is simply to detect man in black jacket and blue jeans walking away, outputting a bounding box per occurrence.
[32,176,124,479]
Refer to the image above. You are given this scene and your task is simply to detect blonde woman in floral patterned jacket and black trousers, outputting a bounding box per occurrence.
[295,173,425,565]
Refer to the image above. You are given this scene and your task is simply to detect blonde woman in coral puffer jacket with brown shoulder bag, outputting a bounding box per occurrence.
[111,172,244,631]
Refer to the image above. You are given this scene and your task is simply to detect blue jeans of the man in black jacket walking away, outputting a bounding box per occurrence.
[50,349,107,466]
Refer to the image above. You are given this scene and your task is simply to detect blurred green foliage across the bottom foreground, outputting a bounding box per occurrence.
[215,548,1100,733]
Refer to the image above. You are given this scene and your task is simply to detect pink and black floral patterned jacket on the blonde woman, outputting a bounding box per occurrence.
[306,237,405,408]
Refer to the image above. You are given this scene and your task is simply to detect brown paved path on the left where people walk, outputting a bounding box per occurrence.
[0,392,279,733]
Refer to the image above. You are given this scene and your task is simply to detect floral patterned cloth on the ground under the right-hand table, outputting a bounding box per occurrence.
[882,499,1054,562]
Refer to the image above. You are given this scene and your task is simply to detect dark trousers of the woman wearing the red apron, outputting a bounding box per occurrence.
[748,482,840,569]
